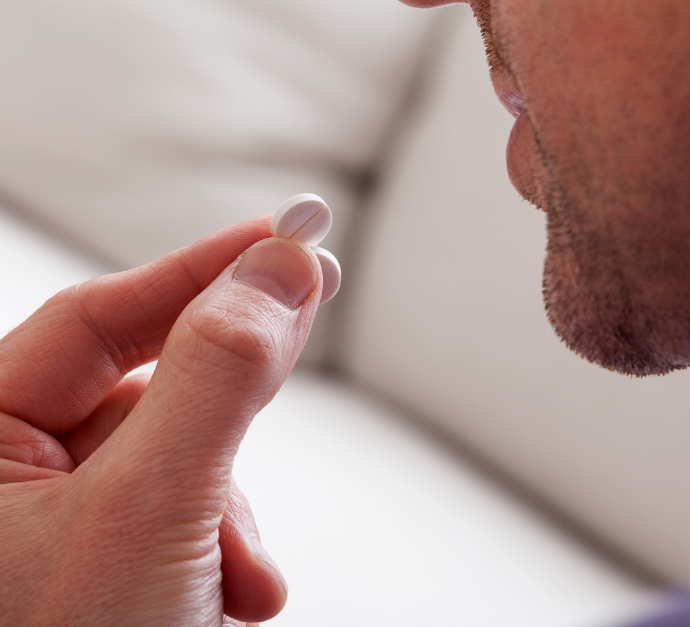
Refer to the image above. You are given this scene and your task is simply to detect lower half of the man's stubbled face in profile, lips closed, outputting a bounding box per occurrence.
[400,0,690,375]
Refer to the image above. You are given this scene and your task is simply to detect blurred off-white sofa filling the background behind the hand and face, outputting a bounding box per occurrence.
[0,0,690,627]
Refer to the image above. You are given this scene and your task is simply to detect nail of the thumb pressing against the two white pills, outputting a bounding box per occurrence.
[235,238,316,309]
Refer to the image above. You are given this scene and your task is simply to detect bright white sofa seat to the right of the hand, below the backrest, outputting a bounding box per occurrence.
[235,373,654,627]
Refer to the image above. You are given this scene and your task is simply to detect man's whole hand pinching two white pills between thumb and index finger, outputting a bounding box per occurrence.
[0,217,321,627]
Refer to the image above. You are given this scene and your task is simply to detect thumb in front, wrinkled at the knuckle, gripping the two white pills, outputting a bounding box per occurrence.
[92,238,321,528]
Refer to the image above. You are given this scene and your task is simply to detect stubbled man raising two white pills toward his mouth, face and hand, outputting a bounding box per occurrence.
[0,0,690,626]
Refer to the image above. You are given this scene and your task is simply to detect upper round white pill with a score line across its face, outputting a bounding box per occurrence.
[271,194,333,246]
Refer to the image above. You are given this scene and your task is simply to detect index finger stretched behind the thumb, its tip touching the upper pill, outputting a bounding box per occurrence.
[0,216,271,433]
